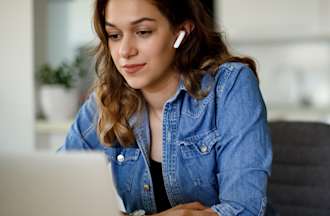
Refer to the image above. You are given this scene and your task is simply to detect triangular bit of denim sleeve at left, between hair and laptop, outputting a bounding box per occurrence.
[58,94,103,152]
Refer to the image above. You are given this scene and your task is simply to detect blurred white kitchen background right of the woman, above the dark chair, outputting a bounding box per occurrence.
[215,0,330,123]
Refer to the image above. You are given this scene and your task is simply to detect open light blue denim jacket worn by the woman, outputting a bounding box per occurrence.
[60,63,272,216]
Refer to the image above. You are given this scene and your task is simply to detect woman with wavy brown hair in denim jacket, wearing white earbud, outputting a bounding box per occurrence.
[61,0,272,216]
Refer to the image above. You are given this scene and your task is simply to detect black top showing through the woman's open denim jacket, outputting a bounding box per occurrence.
[150,160,171,212]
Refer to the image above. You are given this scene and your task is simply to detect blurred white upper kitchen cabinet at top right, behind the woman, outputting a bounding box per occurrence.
[217,0,322,39]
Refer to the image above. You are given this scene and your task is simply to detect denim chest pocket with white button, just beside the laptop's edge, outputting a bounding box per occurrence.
[104,147,141,192]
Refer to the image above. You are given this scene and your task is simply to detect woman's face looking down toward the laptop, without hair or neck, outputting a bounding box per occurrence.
[105,0,178,91]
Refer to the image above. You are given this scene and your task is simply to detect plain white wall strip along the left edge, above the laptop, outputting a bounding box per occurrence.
[0,0,34,151]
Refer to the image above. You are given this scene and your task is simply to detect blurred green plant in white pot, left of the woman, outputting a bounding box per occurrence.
[36,55,87,121]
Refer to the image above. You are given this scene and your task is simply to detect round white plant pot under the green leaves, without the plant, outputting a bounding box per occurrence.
[40,85,79,121]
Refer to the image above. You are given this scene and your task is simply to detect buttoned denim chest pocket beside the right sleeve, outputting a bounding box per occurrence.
[179,130,219,206]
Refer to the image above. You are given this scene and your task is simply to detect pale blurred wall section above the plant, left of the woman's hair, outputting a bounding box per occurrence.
[47,0,95,66]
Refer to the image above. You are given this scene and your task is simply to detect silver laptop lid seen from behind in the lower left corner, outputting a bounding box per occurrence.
[0,152,120,216]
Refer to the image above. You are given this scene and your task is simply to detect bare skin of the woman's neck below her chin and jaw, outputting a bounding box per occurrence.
[142,74,180,116]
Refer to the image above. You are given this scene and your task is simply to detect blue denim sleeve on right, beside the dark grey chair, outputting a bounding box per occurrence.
[212,64,272,216]
